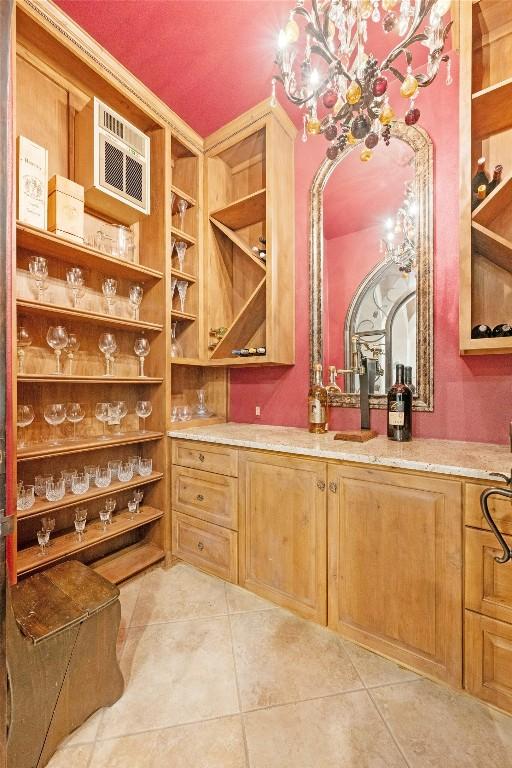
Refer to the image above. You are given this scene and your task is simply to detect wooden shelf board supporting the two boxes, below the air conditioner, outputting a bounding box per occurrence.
[16,222,163,281]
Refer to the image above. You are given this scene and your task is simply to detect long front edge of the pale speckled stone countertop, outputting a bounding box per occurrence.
[167,430,499,483]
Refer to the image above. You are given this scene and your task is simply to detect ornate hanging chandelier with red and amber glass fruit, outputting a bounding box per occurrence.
[271,0,452,161]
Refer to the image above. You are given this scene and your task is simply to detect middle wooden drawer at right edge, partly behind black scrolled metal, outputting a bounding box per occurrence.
[465,528,512,624]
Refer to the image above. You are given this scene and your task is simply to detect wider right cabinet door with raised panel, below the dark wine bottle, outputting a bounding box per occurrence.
[328,465,462,685]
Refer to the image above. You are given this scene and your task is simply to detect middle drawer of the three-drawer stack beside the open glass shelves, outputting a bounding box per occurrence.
[172,466,238,531]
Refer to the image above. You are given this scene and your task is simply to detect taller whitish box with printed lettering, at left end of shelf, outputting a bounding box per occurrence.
[16,136,48,229]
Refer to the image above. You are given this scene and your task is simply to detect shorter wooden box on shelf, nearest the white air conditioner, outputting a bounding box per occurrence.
[48,175,84,243]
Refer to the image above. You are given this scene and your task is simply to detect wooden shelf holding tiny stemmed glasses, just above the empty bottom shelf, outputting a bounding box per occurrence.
[18,506,163,576]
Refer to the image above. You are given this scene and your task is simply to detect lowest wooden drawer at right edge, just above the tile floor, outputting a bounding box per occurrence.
[464,611,512,713]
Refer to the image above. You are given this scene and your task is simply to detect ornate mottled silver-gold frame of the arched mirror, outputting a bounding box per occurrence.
[309,120,434,411]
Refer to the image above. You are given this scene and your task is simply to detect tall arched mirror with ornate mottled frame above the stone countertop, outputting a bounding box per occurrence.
[310,121,433,411]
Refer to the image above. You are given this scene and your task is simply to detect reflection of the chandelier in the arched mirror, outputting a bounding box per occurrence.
[380,181,418,278]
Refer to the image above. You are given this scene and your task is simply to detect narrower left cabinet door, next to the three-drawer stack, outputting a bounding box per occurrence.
[239,451,327,624]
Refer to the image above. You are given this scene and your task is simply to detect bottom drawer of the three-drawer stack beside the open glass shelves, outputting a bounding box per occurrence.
[172,512,238,584]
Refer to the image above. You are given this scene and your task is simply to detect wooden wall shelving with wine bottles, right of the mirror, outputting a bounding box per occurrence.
[459,0,512,355]
